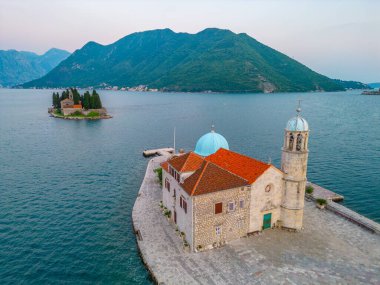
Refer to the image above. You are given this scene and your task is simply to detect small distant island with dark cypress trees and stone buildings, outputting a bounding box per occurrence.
[48,88,112,120]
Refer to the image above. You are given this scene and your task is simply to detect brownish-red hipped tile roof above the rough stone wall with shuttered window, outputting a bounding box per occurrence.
[181,161,249,196]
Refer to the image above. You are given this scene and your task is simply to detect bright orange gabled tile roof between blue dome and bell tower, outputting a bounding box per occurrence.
[205,148,271,184]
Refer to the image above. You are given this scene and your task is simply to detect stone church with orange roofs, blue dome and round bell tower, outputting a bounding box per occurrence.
[161,108,309,251]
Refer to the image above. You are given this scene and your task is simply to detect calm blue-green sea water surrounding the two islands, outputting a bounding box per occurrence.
[0,89,380,284]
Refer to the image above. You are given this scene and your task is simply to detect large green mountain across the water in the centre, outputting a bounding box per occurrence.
[23,28,344,92]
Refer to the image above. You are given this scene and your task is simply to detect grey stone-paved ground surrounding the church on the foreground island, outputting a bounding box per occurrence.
[132,157,380,284]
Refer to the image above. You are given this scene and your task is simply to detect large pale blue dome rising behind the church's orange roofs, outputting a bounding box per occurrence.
[195,131,229,156]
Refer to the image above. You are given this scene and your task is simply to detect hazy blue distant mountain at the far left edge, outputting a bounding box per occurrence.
[0,48,70,86]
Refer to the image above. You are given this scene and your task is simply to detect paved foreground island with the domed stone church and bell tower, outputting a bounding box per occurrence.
[132,107,380,285]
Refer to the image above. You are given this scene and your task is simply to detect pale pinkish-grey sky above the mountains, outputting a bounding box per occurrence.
[0,0,380,83]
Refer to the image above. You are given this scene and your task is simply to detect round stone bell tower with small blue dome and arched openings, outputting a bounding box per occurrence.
[281,105,309,230]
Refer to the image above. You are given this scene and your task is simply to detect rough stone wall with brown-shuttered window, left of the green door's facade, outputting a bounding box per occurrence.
[193,187,250,251]
